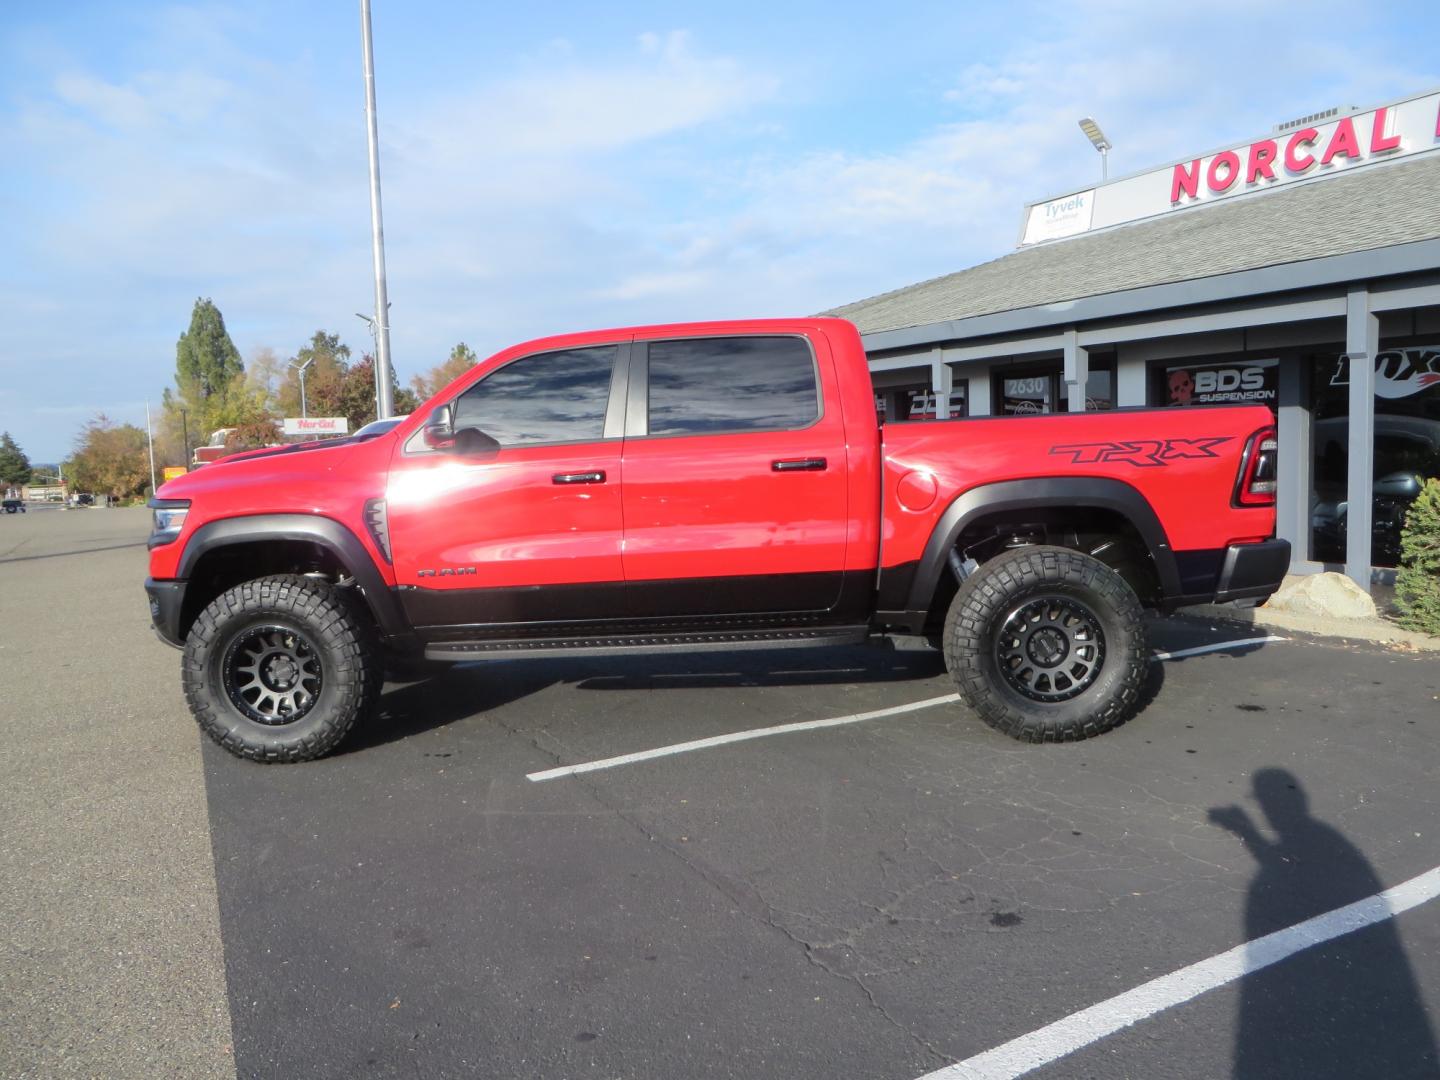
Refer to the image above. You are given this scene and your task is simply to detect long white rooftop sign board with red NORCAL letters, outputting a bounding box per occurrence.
[1020,92,1440,246]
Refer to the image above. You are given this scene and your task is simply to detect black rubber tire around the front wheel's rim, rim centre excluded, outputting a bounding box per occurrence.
[180,575,382,762]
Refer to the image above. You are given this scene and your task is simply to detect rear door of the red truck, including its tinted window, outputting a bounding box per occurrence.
[622,334,848,616]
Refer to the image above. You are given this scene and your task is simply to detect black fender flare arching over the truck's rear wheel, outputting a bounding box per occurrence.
[906,477,1181,622]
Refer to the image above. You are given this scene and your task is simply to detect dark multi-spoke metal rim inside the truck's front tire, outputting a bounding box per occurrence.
[223,626,324,726]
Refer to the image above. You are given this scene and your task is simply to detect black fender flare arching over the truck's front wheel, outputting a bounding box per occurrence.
[176,514,410,638]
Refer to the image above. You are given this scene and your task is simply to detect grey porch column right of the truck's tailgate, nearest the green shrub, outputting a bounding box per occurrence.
[1345,285,1380,592]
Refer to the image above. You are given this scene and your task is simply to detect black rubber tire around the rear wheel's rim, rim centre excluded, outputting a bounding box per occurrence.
[943,546,1146,743]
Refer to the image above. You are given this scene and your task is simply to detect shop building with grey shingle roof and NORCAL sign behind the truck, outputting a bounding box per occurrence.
[825,91,1440,585]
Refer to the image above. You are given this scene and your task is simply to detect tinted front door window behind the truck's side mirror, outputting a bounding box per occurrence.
[454,346,616,446]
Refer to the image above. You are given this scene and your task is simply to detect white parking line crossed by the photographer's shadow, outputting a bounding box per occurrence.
[920,867,1440,1080]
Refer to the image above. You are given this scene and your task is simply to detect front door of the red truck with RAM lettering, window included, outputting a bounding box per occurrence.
[386,341,629,639]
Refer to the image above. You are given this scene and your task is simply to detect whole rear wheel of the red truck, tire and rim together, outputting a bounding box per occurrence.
[945,546,1145,743]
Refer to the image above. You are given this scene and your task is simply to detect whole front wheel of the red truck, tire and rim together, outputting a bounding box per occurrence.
[181,575,380,762]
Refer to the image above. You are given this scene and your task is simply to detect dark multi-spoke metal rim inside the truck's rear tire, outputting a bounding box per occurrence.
[995,596,1104,704]
